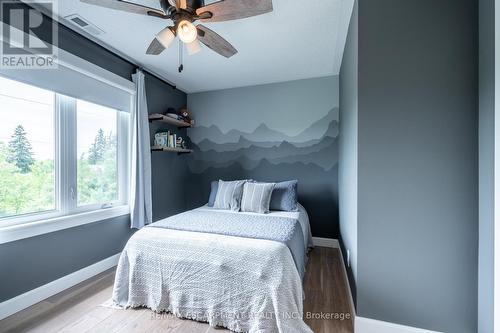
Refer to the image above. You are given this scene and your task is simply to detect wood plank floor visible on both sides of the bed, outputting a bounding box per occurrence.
[0,247,354,333]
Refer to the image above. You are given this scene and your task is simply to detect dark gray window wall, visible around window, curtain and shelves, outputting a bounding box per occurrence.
[0,5,187,302]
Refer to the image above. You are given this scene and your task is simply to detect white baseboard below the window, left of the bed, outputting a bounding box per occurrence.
[0,253,120,320]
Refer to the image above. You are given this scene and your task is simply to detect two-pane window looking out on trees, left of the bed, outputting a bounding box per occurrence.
[0,77,128,228]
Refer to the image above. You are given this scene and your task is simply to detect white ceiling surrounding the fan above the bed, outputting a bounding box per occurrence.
[47,0,354,93]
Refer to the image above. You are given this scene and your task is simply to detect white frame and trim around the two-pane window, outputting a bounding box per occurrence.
[0,44,135,244]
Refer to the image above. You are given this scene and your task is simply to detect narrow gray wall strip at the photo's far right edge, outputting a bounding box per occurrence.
[478,0,495,333]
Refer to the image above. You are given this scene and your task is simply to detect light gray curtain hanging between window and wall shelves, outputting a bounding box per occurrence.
[129,70,153,229]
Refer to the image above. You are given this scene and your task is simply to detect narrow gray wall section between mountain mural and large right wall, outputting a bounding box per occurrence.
[339,1,358,299]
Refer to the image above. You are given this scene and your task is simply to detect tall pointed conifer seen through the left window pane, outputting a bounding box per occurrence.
[7,125,35,173]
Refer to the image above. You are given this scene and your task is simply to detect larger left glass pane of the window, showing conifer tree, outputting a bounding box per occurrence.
[0,77,56,218]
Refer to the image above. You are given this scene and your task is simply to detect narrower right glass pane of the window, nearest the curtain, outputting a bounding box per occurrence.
[76,100,118,206]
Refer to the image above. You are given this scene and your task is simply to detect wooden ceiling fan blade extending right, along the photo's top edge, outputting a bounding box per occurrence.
[196,0,273,22]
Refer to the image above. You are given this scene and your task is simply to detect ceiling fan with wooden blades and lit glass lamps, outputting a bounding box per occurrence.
[80,0,273,64]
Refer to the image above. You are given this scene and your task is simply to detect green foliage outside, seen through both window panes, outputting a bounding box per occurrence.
[0,129,118,218]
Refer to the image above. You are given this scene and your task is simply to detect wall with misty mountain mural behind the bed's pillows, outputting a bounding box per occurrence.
[188,76,338,238]
